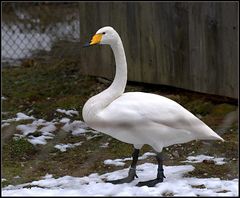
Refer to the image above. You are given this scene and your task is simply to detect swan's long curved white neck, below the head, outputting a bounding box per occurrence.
[83,37,127,124]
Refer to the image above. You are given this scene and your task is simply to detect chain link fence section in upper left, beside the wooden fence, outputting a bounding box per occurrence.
[2,2,80,65]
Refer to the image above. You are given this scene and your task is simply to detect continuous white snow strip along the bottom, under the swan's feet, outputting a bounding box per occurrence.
[2,163,238,196]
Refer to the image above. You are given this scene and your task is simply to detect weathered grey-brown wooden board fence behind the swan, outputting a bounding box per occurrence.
[79,2,238,98]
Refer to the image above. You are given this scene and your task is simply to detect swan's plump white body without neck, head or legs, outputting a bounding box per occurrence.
[89,92,220,152]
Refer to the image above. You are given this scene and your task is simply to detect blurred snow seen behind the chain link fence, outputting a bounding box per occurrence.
[2,19,80,61]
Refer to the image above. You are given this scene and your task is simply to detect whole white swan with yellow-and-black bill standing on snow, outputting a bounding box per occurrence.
[83,26,223,186]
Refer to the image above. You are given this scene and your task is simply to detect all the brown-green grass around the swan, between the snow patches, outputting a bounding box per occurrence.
[2,60,238,187]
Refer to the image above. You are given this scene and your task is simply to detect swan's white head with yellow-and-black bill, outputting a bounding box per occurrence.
[85,26,119,47]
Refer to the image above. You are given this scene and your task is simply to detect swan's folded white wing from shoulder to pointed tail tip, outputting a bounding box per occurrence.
[99,92,223,139]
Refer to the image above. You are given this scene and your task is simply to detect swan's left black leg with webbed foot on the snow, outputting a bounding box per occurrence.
[106,148,139,184]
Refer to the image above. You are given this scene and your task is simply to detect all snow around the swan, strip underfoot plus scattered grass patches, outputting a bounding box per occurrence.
[2,109,238,196]
